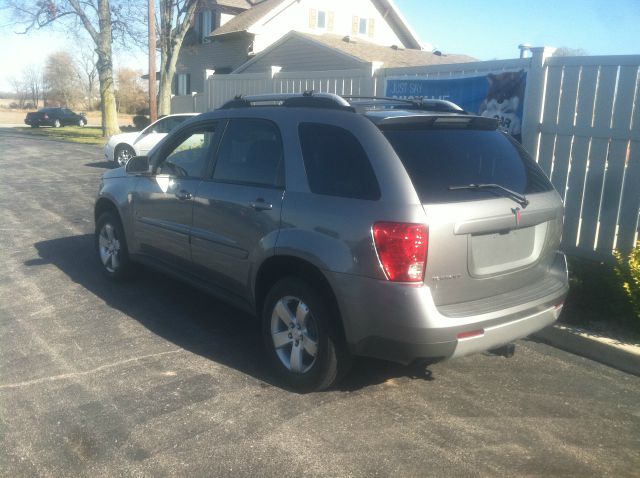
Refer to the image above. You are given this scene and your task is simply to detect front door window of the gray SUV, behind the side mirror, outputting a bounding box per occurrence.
[157,125,215,178]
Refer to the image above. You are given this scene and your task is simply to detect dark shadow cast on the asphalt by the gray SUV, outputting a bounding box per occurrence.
[25,234,432,391]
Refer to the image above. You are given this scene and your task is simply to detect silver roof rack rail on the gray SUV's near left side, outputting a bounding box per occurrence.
[220,91,355,111]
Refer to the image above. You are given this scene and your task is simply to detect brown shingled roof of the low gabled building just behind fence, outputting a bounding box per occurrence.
[235,31,477,73]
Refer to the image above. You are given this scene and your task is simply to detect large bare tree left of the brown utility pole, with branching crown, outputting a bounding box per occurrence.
[4,0,146,136]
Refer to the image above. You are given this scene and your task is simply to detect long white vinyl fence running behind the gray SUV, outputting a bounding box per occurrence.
[172,48,640,261]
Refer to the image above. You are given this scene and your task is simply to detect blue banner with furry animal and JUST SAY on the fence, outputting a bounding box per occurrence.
[385,70,527,141]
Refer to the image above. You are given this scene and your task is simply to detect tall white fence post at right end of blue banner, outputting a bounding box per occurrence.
[522,47,555,156]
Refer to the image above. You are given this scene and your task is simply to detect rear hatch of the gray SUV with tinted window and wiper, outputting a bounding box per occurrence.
[378,115,562,316]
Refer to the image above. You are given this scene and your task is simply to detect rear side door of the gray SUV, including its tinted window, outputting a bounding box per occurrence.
[191,119,284,299]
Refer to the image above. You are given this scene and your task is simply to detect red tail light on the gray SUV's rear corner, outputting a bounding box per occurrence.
[373,222,429,282]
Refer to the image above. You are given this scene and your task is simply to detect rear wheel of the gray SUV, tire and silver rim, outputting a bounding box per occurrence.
[262,277,350,393]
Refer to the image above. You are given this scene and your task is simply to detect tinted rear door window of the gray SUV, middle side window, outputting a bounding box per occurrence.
[213,119,284,187]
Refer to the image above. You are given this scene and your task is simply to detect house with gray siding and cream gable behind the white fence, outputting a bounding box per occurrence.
[174,0,468,95]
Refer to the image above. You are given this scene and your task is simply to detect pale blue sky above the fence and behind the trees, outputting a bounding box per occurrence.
[0,0,640,91]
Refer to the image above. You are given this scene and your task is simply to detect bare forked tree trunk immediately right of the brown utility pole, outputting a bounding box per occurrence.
[158,0,200,115]
